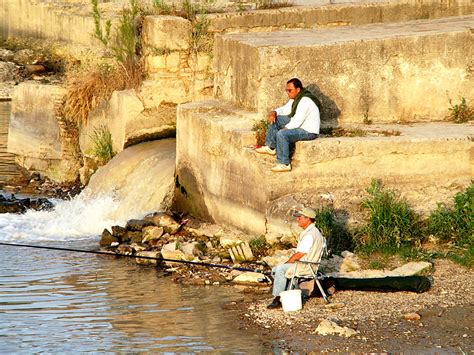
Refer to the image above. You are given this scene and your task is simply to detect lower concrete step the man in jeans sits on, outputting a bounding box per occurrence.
[174,100,474,235]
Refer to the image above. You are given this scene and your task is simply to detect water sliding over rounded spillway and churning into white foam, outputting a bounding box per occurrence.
[0,139,176,241]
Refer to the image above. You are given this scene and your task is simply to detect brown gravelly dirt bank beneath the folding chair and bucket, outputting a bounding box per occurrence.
[229,260,474,354]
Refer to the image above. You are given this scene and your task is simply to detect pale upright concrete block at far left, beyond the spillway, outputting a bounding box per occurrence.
[8,83,64,181]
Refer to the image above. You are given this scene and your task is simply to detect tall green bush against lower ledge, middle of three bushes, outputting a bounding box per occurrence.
[356,180,421,249]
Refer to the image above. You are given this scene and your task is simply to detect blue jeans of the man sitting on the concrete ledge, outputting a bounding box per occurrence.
[265,116,318,165]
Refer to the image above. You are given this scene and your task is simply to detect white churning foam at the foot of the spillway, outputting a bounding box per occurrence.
[0,194,137,241]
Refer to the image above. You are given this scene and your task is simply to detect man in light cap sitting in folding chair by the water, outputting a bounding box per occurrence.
[267,208,324,309]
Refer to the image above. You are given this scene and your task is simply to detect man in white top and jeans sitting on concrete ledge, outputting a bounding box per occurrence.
[256,78,320,172]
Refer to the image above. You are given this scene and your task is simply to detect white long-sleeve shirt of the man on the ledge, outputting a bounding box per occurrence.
[275,96,321,134]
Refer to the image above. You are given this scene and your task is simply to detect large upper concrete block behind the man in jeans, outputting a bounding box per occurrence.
[214,15,474,125]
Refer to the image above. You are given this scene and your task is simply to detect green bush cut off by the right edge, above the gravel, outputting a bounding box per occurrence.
[427,183,474,246]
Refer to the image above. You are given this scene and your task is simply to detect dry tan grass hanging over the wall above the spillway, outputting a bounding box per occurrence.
[61,61,144,126]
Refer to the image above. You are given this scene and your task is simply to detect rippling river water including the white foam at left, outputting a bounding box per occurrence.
[0,103,274,354]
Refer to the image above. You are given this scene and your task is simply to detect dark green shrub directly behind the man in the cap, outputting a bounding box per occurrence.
[314,206,354,254]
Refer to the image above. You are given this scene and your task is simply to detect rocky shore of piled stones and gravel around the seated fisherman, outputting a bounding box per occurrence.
[96,212,474,353]
